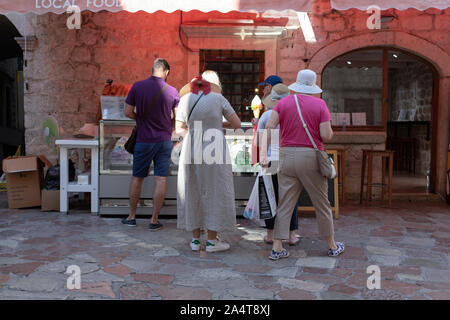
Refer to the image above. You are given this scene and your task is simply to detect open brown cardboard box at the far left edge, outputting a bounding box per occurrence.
[3,156,51,209]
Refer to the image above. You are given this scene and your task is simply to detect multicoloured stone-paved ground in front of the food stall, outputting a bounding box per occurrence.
[0,195,450,300]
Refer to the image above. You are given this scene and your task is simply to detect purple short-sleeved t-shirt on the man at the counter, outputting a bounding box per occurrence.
[126,76,180,142]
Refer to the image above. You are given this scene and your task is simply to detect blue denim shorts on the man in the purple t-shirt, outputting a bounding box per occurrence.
[133,141,173,178]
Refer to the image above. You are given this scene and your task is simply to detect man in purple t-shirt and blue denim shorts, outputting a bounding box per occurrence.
[122,59,180,231]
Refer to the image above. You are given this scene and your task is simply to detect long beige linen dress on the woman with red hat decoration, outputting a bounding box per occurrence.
[176,91,236,232]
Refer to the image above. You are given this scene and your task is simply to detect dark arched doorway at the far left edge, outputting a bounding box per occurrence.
[0,15,24,173]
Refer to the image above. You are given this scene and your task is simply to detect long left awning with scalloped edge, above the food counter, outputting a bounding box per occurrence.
[0,0,313,14]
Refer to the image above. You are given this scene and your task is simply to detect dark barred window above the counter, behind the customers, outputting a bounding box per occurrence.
[200,50,264,122]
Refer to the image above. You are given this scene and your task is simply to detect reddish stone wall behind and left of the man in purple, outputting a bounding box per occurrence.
[25,12,187,161]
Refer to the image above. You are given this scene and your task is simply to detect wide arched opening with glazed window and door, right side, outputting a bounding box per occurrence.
[322,47,438,194]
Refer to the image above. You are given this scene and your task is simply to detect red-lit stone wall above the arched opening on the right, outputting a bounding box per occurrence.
[279,0,450,82]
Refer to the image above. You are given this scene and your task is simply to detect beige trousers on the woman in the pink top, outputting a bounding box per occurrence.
[274,147,334,240]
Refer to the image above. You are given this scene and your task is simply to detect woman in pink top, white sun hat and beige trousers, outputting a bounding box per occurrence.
[261,69,345,260]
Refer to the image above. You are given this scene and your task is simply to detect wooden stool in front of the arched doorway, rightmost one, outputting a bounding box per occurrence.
[359,150,394,207]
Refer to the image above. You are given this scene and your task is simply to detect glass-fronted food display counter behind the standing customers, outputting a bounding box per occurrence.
[99,120,259,215]
